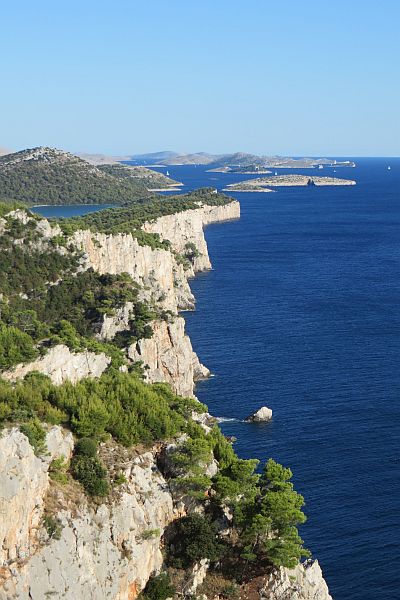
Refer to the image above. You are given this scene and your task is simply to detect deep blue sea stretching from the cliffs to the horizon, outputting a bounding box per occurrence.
[34,157,400,600]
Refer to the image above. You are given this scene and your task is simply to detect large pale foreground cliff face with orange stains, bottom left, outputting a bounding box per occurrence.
[0,427,175,600]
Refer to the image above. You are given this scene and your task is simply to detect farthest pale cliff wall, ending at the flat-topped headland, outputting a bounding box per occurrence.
[71,201,240,313]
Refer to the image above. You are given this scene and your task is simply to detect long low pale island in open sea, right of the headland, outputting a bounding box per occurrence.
[224,175,356,192]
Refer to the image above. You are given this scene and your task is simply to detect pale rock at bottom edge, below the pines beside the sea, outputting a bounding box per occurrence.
[260,560,332,600]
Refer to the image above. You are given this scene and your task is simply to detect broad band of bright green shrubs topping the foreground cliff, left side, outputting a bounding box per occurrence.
[0,371,193,446]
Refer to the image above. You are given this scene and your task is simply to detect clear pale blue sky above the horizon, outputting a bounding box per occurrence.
[0,0,400,156]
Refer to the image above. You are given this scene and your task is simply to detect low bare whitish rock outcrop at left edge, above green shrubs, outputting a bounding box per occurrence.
[2,344,111,384]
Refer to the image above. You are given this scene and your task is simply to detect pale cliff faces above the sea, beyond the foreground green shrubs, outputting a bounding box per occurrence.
[74,202,240,396]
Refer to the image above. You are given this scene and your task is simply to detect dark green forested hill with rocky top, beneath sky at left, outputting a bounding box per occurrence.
[0,147,180,204]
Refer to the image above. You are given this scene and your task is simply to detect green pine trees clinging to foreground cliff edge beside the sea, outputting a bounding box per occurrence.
[166,424,309,567]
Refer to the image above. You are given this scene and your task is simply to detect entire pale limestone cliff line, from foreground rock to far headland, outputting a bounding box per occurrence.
[0,202,331,600]
